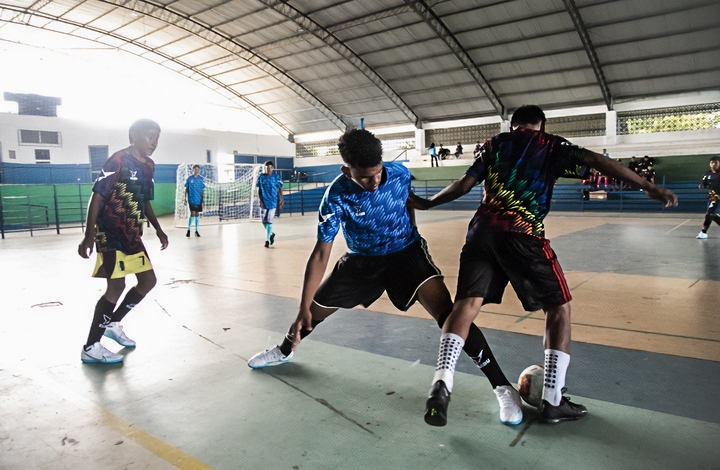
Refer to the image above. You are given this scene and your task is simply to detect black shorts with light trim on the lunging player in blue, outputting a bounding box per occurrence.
[313,238,442,312]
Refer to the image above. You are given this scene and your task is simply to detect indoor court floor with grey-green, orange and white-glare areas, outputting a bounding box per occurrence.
[0,211,720,470]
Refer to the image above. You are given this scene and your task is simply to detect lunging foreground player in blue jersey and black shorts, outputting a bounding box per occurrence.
[248,129,522,424]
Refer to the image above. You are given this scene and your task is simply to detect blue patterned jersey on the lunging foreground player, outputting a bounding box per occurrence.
[317,163,420,256]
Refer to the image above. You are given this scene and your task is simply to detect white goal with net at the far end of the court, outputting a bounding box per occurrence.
[175,163,262,227]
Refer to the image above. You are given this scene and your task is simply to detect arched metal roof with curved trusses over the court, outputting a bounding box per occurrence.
[0,0,720,139]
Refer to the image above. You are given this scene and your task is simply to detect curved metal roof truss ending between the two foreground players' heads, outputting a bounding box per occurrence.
[260,0,420,127]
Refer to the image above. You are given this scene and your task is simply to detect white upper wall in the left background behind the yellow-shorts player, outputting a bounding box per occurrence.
[0,113,295,164]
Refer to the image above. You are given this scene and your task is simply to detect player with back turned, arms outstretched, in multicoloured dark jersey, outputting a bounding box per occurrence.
[410,106,677,425]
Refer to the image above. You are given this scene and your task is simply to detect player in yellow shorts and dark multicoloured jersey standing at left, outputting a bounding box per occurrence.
[78,119,168,364]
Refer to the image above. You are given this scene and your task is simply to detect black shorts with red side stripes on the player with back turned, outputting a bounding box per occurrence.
[455,231,572,312]
